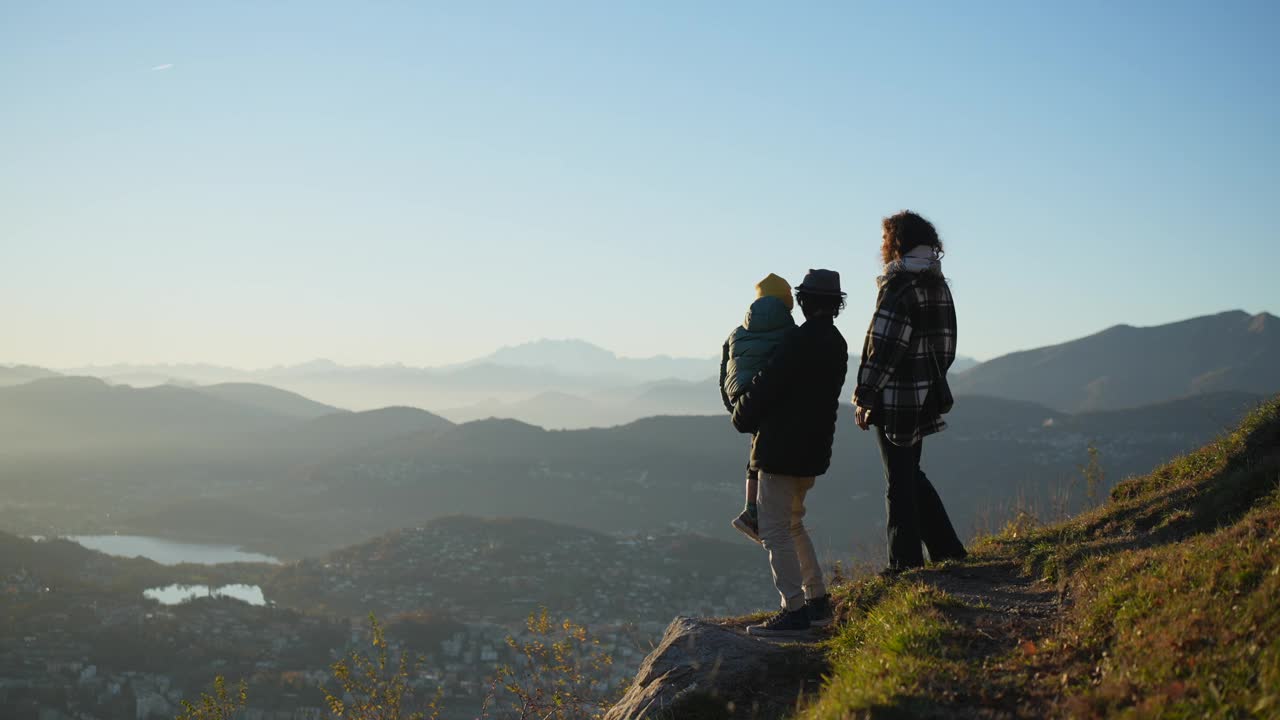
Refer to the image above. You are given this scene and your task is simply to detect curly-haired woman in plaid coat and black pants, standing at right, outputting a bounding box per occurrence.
[854,211,966,574]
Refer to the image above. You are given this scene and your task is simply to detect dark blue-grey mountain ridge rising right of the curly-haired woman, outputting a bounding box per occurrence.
[951,310,1280,413]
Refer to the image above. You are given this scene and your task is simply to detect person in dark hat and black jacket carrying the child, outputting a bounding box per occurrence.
[733,270,849,635]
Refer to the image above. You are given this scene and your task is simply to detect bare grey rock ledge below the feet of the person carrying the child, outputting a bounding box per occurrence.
[605,609,827,720]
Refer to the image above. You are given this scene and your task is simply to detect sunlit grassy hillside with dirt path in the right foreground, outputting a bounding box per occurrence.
[797,397,1280,720]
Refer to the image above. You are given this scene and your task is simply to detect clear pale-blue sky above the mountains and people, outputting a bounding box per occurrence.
[0,1,1280,366]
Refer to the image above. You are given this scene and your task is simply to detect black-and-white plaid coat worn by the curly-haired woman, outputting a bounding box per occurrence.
[854,270,956,446]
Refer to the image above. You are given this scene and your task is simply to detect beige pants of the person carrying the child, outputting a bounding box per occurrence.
[756,473,827,611]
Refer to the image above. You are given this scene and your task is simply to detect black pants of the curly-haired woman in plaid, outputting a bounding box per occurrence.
[876,428,968,569]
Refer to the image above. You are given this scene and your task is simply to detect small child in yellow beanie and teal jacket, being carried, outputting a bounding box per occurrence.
[719,273,796,542]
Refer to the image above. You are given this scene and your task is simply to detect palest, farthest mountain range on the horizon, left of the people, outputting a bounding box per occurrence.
[32,340,974,429]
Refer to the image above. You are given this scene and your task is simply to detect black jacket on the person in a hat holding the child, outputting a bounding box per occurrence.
[733,318,849,478]
